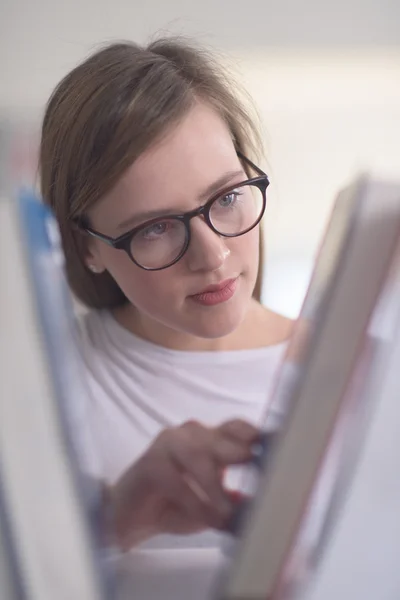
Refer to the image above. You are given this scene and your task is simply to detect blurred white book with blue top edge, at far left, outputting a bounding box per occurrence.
[0,193,111,600]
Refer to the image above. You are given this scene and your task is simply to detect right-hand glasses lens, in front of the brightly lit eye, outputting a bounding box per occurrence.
[210,185,264,235]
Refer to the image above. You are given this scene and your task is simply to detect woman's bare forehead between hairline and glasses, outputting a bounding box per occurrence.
[95,103,240,225]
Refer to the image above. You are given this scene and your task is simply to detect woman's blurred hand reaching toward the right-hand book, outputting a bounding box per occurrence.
[110,420,259,550]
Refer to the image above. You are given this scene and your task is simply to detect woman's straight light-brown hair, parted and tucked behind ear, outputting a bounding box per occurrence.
[40,38,262,308]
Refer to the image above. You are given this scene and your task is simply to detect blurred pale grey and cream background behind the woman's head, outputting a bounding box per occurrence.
[0,0,400,316]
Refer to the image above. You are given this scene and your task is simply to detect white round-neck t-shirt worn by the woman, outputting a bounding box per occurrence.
[76,311,286,545]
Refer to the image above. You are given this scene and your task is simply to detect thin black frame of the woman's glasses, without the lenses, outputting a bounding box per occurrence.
[75,152,270,271]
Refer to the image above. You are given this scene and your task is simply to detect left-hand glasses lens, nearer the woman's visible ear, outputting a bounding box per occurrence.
[131,219,187,269]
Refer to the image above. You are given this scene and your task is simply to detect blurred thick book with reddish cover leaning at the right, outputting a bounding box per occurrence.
[217,176,400,600]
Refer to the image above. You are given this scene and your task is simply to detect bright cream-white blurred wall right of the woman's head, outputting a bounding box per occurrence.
[240,48,400,316]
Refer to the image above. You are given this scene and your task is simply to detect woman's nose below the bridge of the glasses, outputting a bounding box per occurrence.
[186,217,230,271]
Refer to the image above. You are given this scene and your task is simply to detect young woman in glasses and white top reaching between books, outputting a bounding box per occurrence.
[40,39,291,546]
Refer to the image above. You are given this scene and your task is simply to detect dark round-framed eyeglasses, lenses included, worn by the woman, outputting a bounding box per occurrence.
[78,153,269,271]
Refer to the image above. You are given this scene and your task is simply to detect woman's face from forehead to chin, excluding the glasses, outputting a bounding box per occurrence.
[87,103,259,338]
